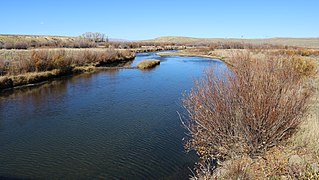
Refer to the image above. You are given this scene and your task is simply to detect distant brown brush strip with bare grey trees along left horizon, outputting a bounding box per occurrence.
[0,32,182,52]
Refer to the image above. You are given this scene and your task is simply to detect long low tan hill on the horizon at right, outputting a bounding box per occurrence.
[143,36,319,48]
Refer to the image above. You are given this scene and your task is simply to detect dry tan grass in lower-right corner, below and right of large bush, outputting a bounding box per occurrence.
[212,75,319,179]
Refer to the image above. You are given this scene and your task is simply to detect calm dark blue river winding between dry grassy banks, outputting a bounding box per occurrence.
[0,52,227,179]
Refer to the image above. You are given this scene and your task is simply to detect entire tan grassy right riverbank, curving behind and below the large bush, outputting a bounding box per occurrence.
[175,48,319,179]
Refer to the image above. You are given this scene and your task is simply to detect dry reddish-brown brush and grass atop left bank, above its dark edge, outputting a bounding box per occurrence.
[0,48,135,75]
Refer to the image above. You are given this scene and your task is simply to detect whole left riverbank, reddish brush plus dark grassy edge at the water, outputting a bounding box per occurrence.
[0,48,135,90]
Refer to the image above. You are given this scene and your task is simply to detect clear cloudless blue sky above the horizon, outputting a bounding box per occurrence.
[0,0,319,40]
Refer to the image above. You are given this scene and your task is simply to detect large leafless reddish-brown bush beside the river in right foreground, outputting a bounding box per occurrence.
[183,54,312,165]
